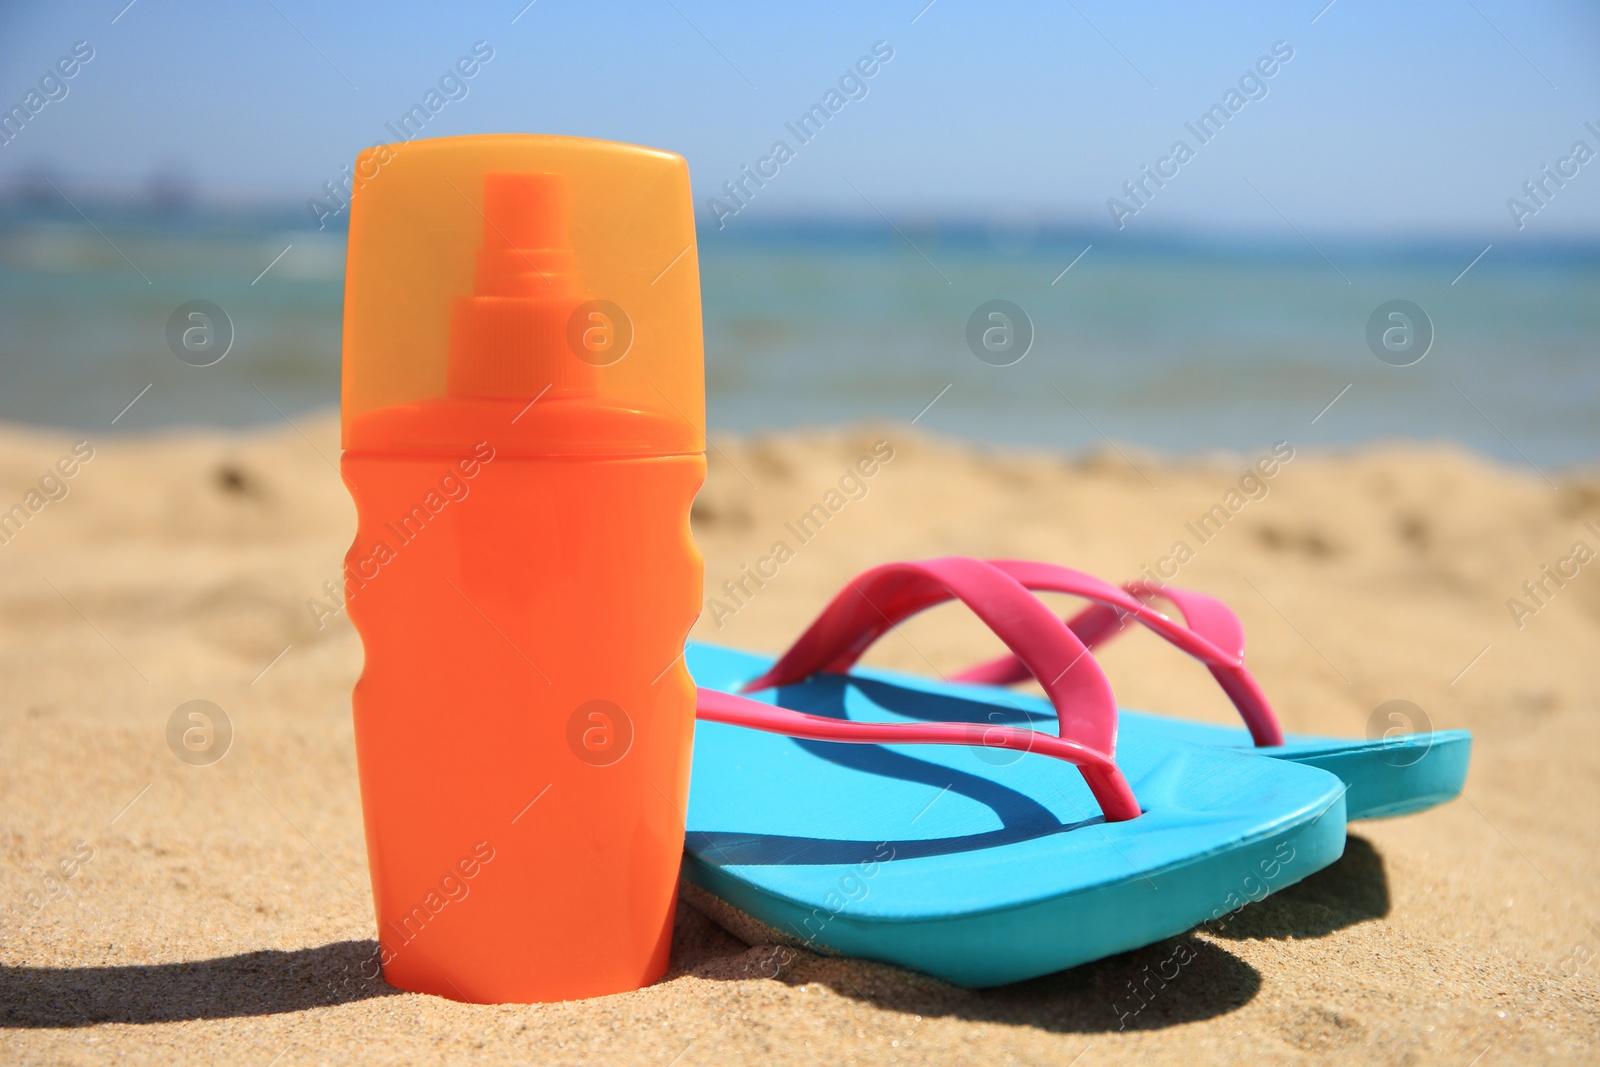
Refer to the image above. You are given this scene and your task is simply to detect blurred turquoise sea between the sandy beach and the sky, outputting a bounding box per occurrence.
[0,202,1600,469]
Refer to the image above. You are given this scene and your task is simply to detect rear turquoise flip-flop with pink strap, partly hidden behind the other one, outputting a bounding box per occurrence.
[950,560,1472,821]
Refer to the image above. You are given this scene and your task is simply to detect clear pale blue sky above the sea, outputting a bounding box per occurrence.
[0,0,1600,238]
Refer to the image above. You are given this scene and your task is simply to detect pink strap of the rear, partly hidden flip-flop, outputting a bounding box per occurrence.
[952,560,1283,745]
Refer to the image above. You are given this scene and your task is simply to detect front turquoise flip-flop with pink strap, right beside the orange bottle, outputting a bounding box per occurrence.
[683,558,1344,987]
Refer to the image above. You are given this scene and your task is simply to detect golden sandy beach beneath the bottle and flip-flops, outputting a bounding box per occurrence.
[0,416,1600,1067]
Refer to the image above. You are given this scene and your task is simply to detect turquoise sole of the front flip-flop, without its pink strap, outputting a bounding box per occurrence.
[685,643,1346,987]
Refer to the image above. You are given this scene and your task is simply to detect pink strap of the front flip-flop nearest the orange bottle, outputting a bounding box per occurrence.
[726,557,1139,822]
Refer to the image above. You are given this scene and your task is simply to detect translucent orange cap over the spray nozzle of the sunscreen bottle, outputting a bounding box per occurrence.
[341,134,706,456]
